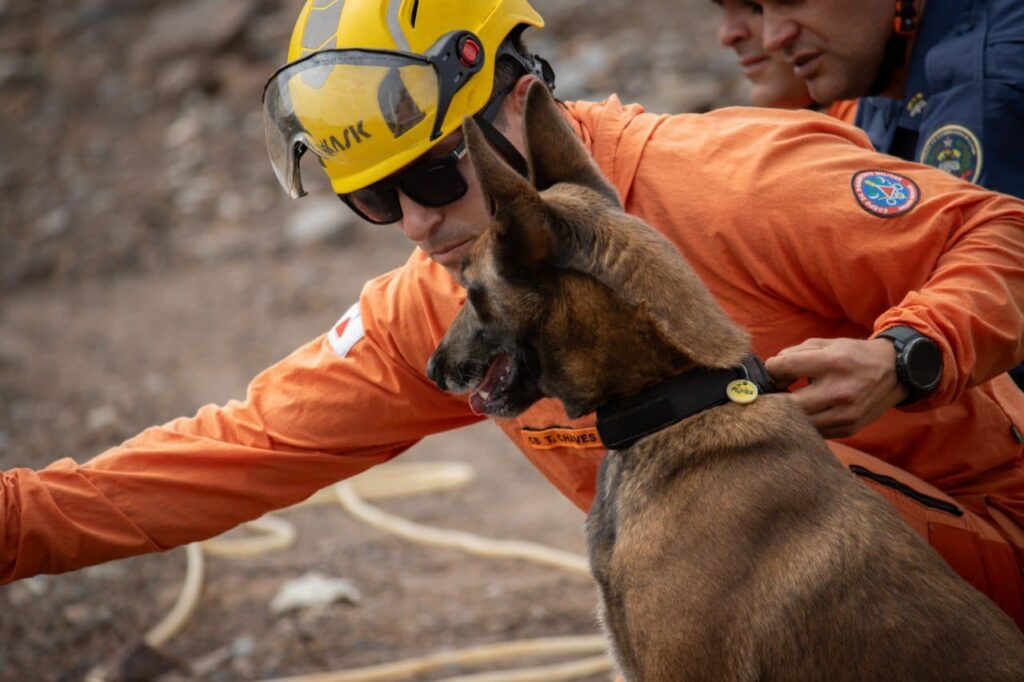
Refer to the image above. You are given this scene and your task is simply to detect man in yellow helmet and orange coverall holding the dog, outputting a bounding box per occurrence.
[0,0,1024,625]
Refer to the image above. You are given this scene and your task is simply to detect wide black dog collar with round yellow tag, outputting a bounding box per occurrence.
[597,355,778,450]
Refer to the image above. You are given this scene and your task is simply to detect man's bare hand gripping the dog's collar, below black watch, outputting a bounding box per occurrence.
[765,339,906,438]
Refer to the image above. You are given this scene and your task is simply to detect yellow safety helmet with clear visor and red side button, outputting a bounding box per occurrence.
[263,0,550,198]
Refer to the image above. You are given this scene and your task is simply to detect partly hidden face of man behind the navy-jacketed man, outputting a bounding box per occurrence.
[714,0,811,109]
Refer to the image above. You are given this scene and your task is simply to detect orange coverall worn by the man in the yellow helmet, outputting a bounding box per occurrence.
[0,97,1024,624]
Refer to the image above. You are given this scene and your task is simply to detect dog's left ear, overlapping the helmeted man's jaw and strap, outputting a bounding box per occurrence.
[462,116,554,264]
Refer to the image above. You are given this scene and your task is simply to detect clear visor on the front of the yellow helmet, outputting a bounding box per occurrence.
[263,50,439,198]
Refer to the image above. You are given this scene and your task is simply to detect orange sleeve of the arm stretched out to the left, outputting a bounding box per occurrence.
[0,251,478,583]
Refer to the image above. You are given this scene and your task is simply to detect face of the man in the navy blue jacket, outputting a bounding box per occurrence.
[761,0,895,104]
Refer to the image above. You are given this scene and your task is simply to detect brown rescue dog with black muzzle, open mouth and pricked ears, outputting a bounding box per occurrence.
[427,84,1024,682]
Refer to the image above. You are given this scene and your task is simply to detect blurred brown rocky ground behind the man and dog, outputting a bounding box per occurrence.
[0,0,745,680]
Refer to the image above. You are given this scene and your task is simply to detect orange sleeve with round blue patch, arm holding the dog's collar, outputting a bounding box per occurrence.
[638,109,1024,408]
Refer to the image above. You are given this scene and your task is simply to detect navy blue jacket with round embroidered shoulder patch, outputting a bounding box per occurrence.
[856,0,1024,199]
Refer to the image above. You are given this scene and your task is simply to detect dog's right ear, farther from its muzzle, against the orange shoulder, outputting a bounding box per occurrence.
[524,81,621,206]
